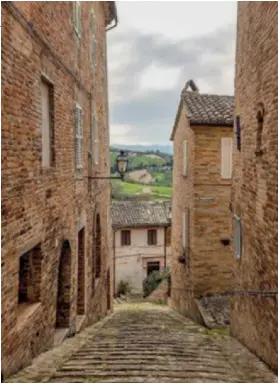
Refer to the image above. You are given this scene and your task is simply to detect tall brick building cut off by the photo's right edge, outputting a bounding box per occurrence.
[231,2,278,370]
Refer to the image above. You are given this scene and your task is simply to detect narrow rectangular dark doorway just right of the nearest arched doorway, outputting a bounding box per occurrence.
[77,228,85,315]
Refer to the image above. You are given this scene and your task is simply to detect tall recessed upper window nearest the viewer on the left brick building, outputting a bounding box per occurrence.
[41,79,54,168]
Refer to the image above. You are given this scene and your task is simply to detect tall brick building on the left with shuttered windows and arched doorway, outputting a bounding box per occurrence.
[1,1,117,375]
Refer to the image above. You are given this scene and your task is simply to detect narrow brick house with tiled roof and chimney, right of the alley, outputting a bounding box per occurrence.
[171,80,234,315]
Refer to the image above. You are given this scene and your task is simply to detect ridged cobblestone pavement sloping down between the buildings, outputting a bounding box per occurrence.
[6,303,278,383]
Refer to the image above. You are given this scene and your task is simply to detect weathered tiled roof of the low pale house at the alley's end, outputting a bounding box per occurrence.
[111,202,172,227]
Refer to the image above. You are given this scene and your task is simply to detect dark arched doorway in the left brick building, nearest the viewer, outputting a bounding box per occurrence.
[56,241,71,327]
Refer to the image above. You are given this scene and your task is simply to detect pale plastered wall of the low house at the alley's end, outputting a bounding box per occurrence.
[115,227,170,294]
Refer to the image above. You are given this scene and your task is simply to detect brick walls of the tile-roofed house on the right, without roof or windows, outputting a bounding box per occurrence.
[171,105,235,314]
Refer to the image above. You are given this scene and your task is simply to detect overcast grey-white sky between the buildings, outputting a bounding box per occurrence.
[108,1,236,144]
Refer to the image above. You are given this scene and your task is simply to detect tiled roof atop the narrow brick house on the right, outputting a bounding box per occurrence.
[181,91,234,126]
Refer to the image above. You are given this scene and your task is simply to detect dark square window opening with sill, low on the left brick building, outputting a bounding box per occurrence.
[18,245,42,304]
